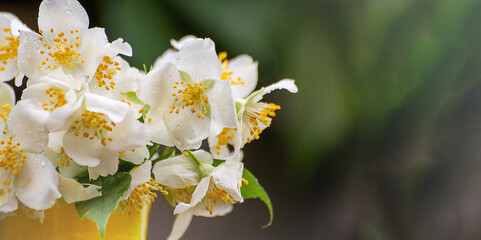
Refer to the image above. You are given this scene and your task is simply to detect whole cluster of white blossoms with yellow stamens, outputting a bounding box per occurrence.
[0,0,297,239]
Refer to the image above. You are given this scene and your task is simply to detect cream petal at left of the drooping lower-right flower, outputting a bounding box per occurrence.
[152,155,200,188]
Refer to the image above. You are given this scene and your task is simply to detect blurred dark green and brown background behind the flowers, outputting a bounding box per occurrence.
[6,0,481,240]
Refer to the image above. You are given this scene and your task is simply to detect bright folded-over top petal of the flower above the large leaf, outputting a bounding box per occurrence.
[84,93,129,123]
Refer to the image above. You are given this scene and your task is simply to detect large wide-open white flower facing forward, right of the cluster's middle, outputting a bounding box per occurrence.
[138,39,237,150]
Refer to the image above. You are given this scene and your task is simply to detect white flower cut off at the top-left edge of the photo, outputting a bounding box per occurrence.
[0,12,31,86]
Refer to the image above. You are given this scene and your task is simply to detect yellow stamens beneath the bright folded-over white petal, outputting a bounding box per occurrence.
[70,109,116,146]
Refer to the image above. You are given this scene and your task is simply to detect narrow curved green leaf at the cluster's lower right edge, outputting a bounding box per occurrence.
[241,168,274,228]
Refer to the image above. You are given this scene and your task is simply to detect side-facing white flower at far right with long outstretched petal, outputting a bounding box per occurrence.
[209,79,297,159]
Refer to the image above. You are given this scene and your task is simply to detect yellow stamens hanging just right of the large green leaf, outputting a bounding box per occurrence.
[121,178,168,215]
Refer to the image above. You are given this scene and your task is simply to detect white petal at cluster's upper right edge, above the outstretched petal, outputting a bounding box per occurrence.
[229,54,258,98]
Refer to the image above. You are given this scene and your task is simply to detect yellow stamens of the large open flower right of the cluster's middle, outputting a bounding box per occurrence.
[169,81,209,119]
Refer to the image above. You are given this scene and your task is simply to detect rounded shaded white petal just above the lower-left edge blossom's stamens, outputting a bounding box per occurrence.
[9,99,49,152]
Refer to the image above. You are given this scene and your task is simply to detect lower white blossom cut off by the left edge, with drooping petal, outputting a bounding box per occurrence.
[0,104,61,216]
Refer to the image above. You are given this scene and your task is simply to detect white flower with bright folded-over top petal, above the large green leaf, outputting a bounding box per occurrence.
[62,93,148,179]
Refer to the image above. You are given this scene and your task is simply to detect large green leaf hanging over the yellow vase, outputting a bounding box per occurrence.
[75,172,132,239]
